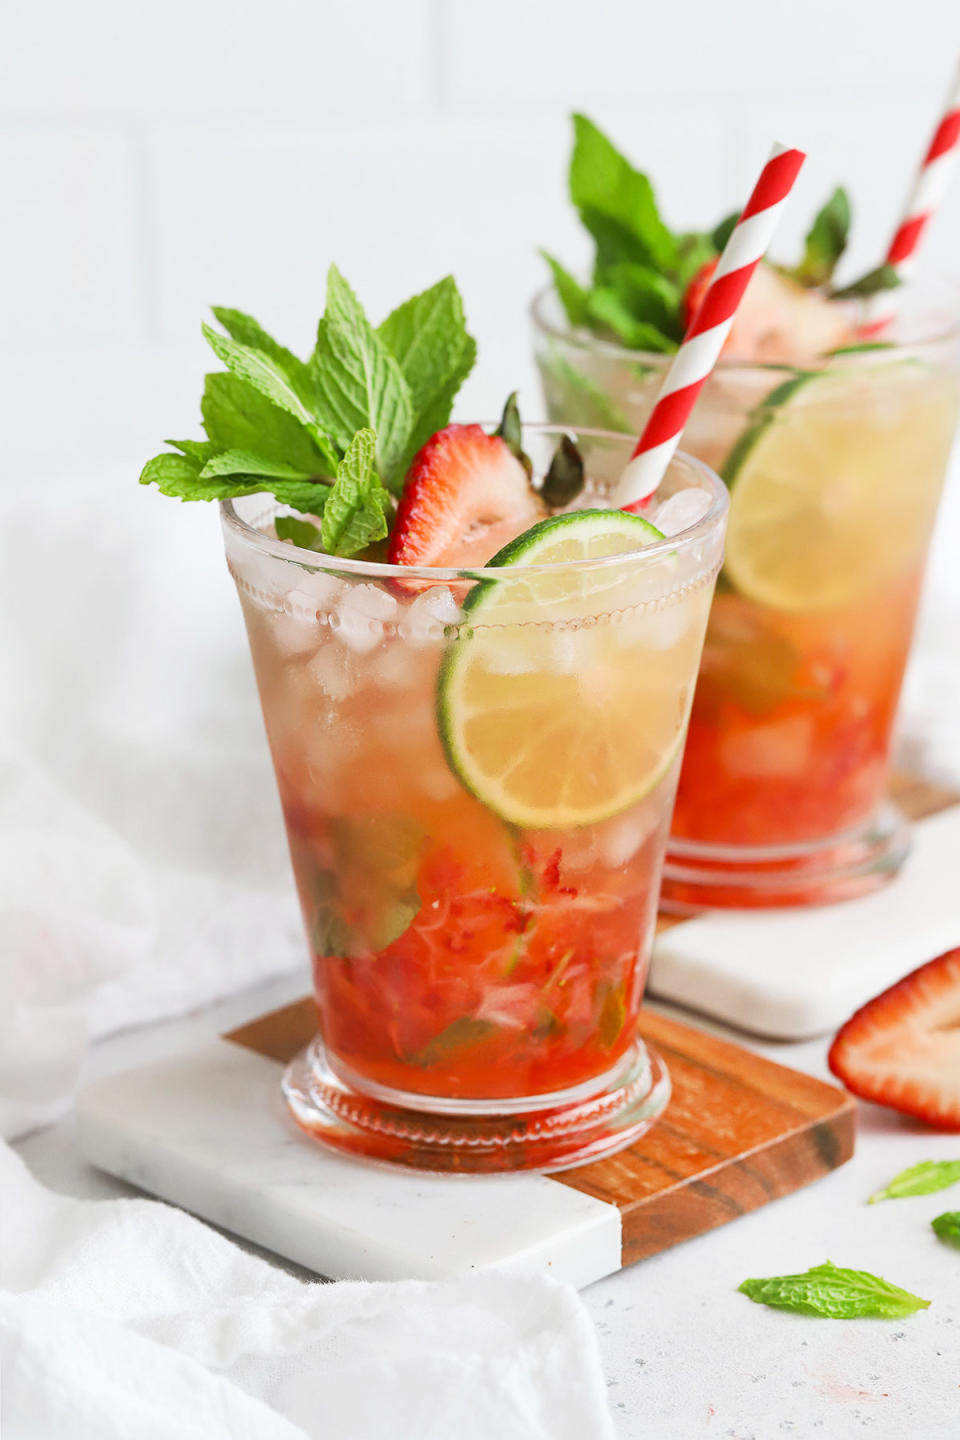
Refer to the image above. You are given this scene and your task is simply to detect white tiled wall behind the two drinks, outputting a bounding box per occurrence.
[0,0,960,478]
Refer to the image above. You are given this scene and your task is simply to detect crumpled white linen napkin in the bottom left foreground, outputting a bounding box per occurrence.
[0,1142,613,1440]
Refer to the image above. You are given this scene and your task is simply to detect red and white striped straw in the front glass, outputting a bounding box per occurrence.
[613,145,806,510]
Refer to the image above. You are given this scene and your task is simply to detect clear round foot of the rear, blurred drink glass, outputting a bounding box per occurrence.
[661,802,910,914]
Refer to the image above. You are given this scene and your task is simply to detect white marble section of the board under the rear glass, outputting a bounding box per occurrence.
[649,806,960,1040]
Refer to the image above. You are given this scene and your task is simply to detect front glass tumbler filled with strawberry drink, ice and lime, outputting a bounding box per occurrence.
[223,426,727,1171]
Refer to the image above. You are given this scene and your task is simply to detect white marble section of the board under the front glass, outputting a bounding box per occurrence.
[78,1040,620,1286]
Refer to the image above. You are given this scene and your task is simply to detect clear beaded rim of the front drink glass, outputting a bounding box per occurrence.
[220,420,730,583]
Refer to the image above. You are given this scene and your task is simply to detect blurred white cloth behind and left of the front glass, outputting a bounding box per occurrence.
[0,468,307,1136]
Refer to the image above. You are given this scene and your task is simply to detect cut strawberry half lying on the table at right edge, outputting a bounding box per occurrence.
[828,946,960,1130]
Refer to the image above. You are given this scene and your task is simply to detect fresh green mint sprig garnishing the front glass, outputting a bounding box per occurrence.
[140,266,476,556]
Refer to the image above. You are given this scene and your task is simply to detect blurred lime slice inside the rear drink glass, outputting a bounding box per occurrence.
[723,361,957,612]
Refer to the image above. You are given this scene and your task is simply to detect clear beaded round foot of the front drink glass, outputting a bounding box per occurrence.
[284,1037,671,1175]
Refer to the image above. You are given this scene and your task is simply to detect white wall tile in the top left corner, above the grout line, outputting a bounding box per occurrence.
[0,0,433,120]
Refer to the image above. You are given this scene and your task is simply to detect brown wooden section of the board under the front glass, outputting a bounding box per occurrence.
[225,999,855,1266]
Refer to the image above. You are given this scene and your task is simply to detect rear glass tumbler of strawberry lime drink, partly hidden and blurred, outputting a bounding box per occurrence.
[533,291,960,913]
